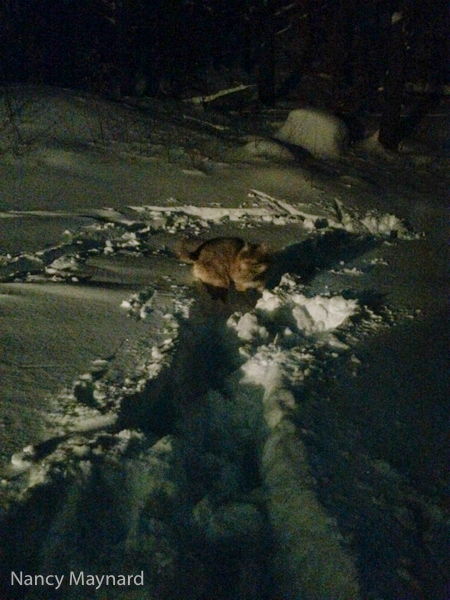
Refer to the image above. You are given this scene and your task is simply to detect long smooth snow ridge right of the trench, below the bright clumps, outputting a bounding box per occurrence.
[261,365,360,600]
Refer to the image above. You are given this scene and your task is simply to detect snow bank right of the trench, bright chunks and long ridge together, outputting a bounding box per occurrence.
[228,275,360,600]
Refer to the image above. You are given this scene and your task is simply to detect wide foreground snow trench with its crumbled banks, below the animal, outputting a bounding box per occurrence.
[0,277,366,600]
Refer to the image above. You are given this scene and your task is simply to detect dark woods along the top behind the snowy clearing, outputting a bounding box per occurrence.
[0,0,449,148]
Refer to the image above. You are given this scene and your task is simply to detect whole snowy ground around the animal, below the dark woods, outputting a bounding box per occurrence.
[0,91,450,600]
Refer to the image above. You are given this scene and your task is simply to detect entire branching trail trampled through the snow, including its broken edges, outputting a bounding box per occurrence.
[0,198,441,600]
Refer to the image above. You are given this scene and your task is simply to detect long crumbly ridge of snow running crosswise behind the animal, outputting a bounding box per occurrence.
[0,190,418,283]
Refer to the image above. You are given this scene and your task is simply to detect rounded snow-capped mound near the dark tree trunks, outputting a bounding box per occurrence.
[275,108,348,158]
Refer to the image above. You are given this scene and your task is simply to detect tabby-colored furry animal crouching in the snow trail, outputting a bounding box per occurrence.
[176,237,271,292]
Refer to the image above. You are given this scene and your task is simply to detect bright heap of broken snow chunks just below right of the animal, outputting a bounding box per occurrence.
[227,274,360,389]
